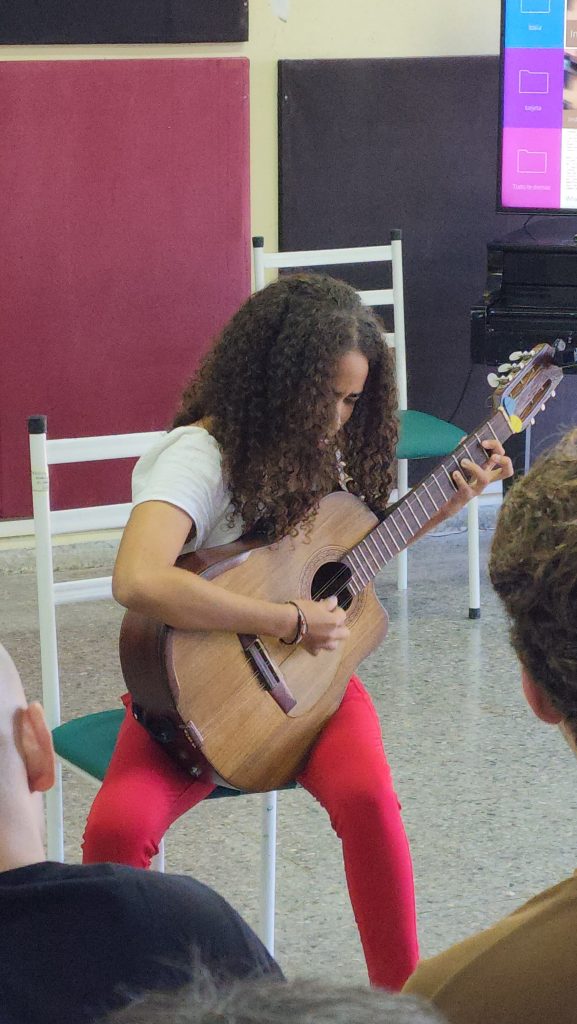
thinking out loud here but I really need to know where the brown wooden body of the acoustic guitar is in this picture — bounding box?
[120,493,388,792]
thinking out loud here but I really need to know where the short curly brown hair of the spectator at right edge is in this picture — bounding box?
[489,430,577,737]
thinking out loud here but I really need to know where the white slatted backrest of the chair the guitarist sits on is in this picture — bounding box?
[28,416,163,729]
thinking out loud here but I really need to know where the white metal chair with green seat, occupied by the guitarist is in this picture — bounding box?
[29,416,284,953]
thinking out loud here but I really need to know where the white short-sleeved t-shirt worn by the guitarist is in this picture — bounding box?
[132,427,244,554]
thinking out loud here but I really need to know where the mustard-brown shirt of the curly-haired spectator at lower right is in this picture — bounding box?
[404,876,577,1024]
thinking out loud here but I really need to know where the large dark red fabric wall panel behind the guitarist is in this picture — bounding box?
[0,58,250,518]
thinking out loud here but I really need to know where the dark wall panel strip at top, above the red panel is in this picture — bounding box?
[0,0,248,44]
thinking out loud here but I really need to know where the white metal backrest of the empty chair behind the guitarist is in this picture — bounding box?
[252,230,407,409]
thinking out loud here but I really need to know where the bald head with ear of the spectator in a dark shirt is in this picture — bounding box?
[0,645,54,871]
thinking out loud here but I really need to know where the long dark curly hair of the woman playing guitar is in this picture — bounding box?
[172,273,398,541]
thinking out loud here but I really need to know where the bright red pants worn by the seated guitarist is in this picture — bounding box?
[84,676,418,990]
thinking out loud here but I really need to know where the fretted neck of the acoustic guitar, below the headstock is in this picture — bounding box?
[342,410,511,593]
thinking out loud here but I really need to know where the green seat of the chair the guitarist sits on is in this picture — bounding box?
[52,709,296,800]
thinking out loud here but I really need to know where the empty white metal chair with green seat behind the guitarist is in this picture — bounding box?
[252,229,481,618]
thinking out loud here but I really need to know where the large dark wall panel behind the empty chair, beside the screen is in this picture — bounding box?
[279,56,577,452]
